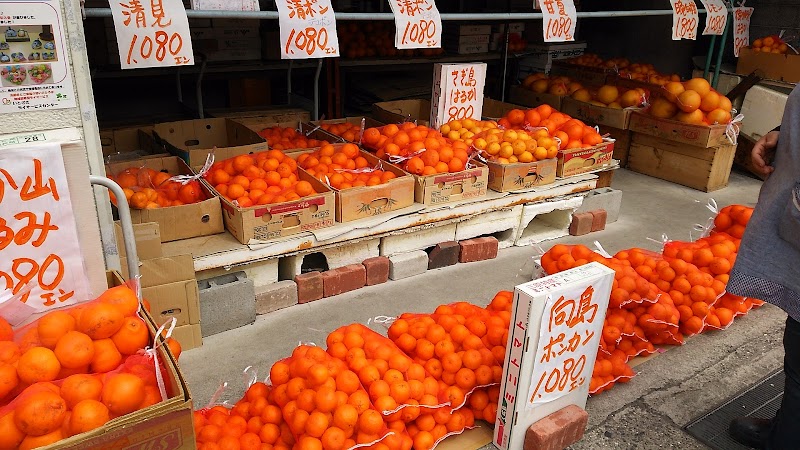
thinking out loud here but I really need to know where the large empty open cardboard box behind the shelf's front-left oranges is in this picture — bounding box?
[154,119,269,168]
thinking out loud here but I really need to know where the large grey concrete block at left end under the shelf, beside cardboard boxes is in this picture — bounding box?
[197,272,256,337]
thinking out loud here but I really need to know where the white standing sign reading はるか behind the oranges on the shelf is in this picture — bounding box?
[430,63,486,128]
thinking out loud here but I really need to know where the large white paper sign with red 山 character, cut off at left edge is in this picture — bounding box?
[0,144,90,311]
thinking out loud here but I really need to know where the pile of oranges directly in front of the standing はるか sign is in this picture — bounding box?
[361,122,476,176]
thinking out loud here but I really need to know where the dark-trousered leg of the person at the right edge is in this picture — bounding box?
[767,317,800,450]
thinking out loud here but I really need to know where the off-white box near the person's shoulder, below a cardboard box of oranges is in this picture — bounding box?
[739,85,789,140]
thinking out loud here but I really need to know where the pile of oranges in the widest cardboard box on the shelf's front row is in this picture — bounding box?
[205,150,317,208]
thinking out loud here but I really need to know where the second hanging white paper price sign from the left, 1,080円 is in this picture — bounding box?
[275,0,339,59]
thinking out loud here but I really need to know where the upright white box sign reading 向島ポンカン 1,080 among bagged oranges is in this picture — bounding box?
[494,263,614,450]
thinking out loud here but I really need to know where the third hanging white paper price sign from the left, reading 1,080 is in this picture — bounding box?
[389,0,442,50]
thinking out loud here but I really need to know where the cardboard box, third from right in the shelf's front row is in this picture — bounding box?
[414,161,489,205]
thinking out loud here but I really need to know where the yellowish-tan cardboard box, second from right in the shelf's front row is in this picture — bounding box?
[486,158,558,192]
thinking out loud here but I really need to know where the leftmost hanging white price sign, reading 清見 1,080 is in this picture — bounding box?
[110,0,194,69]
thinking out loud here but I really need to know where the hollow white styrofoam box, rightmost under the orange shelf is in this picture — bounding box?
[514,196,583,247]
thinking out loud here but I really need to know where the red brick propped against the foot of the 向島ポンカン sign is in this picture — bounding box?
[522,405,589,450]
